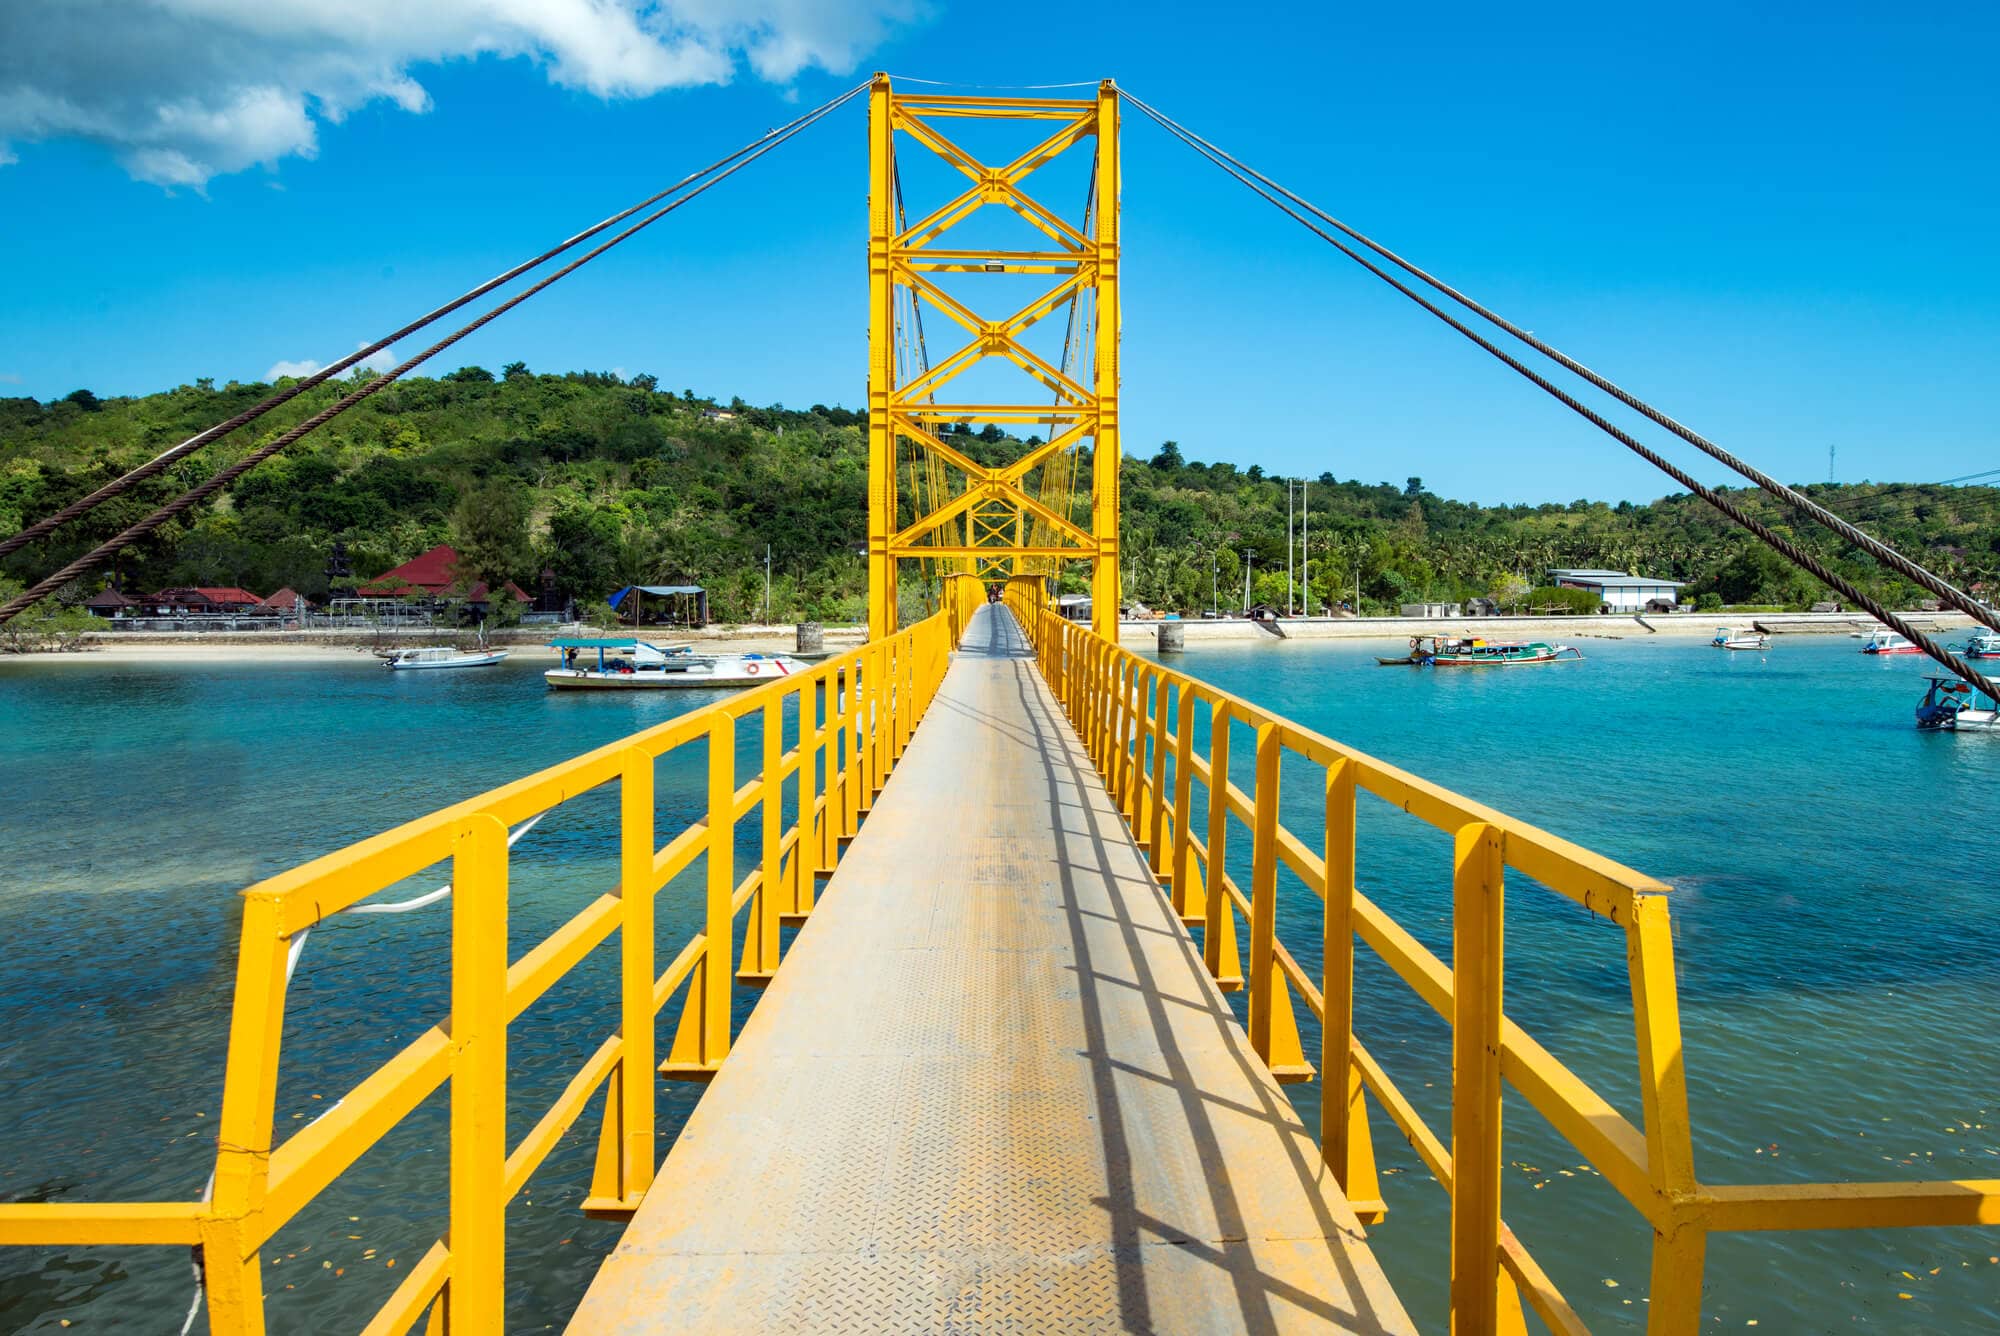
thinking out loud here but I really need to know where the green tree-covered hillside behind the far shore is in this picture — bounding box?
[0,362,2000,620]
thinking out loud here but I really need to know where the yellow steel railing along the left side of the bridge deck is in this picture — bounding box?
[0,612,960,1336]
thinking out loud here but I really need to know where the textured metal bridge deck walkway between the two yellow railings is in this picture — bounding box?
[570,608,1412,1336]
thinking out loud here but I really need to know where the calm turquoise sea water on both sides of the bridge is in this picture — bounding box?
[0,638,2000,1332]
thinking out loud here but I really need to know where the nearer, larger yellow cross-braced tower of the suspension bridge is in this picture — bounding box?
[868,74,1118,636]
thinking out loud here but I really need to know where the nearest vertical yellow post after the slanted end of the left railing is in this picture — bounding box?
[444,812,508,1336]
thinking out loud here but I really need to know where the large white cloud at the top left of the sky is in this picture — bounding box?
[0,0,926,188]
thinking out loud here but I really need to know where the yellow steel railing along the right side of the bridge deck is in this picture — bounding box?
[1006,578,2000,1336]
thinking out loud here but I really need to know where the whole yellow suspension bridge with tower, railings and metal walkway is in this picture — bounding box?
[0,76,2000,1336]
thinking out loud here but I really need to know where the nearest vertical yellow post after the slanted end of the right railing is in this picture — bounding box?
[1452,822,1506,1336]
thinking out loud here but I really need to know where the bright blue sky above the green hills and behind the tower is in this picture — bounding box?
[0,0,2000,502]
